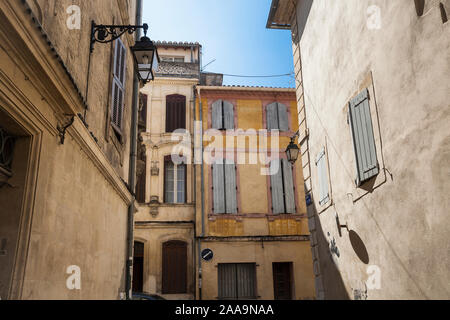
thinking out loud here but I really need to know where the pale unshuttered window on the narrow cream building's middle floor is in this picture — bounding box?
[164,156,187,203]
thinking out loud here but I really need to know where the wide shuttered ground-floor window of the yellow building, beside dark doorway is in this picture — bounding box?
[218,263,257,300]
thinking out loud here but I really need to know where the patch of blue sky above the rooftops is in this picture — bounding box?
[143,0,295,87]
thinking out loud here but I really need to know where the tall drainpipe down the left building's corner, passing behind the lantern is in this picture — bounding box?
[125,0,142,300]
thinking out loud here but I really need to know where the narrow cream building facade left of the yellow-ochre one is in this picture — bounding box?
[133,42,201,299]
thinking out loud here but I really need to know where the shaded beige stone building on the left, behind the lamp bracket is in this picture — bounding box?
[0,0,142,299]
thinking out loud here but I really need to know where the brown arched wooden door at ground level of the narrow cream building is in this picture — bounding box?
[162,241,187,294]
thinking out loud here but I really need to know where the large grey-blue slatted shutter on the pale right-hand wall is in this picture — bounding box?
[349,89,379,186]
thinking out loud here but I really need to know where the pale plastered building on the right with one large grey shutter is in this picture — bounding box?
[267,0,450,299]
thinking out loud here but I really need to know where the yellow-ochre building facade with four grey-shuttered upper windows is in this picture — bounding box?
[194,86,314,300]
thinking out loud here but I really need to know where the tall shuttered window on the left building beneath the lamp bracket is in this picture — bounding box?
[111,39,127,133]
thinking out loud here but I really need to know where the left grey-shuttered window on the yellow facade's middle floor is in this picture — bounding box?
[212,159,238,214]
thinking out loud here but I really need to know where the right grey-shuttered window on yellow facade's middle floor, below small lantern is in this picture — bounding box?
[270,159,297,214]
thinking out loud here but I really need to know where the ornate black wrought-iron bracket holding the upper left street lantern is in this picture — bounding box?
[91,21,148,53]
